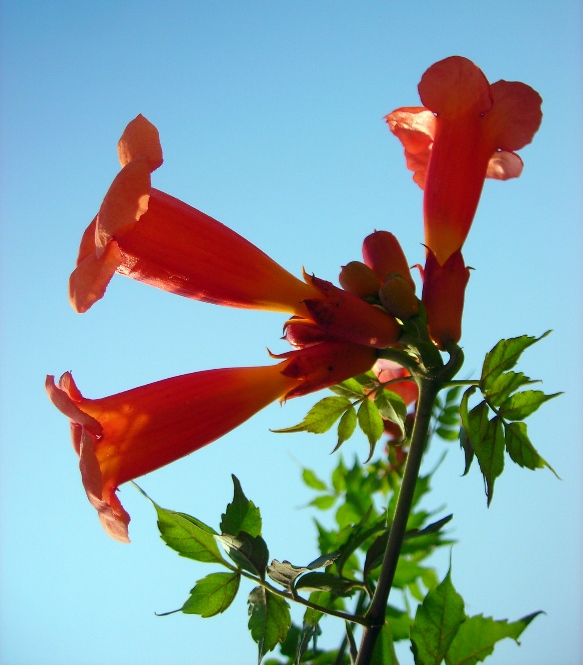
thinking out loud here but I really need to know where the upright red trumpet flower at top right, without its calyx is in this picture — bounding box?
[386,56,542,266]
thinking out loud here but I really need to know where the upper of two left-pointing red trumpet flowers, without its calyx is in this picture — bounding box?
[69,115,324,314]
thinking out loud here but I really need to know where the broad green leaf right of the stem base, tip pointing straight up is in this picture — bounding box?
[411,570,466,665]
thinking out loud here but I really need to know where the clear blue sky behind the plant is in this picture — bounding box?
[0,0,582,665]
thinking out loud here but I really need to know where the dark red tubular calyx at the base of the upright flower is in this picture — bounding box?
[422,251,470,350]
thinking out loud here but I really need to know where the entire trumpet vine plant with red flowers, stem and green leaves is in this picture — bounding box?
[46,56,556,665]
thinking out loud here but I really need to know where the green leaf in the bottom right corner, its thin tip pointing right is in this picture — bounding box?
[445,612,540,665]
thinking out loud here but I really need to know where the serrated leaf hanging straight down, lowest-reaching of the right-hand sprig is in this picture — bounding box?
[469,410,504,505]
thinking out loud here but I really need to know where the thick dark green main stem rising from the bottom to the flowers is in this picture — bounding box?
[355,378,442,665]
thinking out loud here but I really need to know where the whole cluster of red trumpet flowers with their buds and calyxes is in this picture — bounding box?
[46,57,541,542]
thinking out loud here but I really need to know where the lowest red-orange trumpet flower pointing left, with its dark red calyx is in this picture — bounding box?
[46,342,375,542]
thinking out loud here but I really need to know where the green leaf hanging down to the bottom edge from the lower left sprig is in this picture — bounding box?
[248,586,291,663]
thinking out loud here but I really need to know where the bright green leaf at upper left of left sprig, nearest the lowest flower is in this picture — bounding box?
[152,502,226,564]
